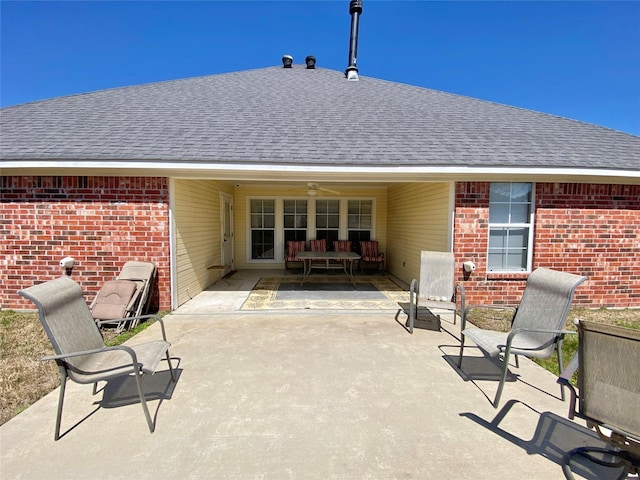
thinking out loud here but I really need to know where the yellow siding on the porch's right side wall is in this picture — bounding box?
[387,183,453,283]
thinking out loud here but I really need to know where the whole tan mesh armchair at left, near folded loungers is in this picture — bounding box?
[18,277,175,440]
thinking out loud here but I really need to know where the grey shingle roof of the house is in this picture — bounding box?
[0,65,640,171]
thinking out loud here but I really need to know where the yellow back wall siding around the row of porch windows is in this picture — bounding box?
[233,184,387,269]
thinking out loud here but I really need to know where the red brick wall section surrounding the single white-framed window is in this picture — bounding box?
[454,182,640,308]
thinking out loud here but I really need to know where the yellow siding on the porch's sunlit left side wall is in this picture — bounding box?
[173,180,233,305]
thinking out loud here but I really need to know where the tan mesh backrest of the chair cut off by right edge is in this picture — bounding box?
[578,320,640,439]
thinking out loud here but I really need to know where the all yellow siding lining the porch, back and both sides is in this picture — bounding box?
[173,180,453,305]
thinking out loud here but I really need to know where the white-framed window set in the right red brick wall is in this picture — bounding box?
[487,183,533,272]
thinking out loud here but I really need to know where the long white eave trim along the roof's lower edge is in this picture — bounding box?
[1,160,640,184]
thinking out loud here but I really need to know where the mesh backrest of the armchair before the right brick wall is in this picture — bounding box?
[511,268,587,356]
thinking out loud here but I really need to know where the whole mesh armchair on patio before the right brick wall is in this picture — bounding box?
[458,268,586,408]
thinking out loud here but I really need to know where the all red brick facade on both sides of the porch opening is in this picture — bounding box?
[0,176,640,310]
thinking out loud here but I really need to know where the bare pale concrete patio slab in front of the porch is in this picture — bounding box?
[0,270,602,480]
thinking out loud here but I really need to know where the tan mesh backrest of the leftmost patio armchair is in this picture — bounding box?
[18,277,104,365]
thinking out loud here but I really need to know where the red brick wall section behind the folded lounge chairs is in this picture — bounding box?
[0,176,171,310]
